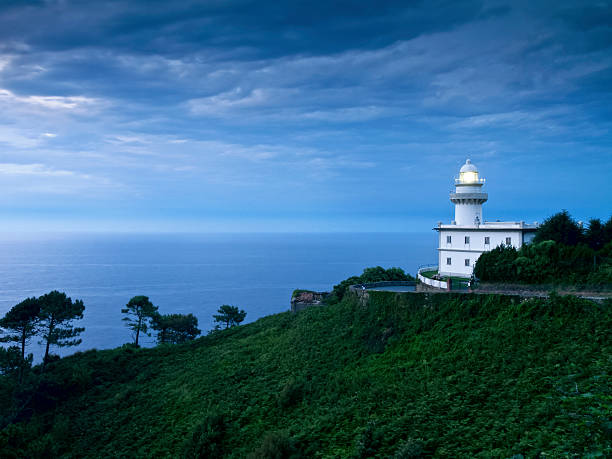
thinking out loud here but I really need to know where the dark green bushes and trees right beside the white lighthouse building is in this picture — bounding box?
[474,211,612,289]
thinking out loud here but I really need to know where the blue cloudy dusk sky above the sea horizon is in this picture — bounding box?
[0,0,612,234]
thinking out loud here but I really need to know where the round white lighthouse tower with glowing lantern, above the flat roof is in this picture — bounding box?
[450,159,489,227]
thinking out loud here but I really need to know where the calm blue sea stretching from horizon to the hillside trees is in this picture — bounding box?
[0,233,436,354]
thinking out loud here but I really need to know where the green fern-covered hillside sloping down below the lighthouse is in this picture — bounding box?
[0,292,612,457]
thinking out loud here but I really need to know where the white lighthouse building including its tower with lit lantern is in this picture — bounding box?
[434,159,538,277]
